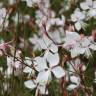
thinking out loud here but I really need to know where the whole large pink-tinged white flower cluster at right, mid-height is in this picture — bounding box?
[63,32,96,58]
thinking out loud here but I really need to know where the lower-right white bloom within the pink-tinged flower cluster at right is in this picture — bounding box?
[70,37,92,58]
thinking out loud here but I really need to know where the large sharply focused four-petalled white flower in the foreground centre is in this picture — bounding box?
[34,53,65,83]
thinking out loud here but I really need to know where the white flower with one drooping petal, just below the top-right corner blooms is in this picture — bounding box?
[71,8,86,31]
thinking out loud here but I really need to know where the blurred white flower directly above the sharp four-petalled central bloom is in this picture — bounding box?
[29,31,58,53]
